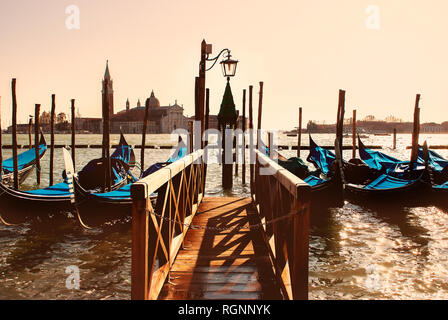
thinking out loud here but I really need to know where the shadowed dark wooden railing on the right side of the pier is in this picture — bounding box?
[251,150,311,300]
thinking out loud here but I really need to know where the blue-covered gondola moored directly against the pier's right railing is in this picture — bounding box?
[278,135,343,208]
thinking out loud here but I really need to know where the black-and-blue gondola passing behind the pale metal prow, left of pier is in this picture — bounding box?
[0,134,135,223]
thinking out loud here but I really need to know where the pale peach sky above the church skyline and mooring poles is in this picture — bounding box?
[0,0,448,130]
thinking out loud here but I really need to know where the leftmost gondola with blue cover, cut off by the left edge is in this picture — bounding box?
[1,133,47,186]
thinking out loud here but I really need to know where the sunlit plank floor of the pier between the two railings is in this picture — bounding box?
[159,198,282,300]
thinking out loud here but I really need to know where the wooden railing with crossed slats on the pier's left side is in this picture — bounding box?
[131,150,205,300]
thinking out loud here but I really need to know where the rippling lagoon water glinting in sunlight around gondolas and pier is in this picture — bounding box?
[0,134,448,299]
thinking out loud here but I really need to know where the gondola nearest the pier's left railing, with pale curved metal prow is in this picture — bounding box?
[66,143,187,225]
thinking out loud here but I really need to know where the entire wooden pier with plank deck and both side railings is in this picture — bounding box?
[131,150,310,300]
